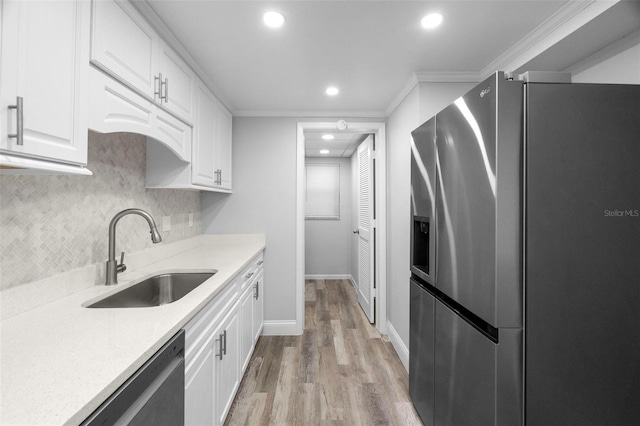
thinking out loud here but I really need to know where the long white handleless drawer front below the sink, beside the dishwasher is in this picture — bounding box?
[184,278,238,362]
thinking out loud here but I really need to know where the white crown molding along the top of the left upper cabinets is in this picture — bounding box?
[131,0,235,115]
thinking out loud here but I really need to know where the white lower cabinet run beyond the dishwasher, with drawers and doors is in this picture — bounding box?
[184,253,263,426]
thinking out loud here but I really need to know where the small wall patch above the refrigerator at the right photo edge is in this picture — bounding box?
[567,31,640,84]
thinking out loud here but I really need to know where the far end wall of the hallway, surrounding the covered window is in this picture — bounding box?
[305,157,352,276]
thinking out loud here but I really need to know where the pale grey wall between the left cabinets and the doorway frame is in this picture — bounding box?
[201,117,381,334]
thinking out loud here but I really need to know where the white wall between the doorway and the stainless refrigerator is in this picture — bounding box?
[387,83,476,367]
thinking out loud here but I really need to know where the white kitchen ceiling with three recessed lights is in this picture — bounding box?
[144,0,640,117]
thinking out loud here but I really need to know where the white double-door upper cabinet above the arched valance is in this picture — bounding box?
[91,0,195,123]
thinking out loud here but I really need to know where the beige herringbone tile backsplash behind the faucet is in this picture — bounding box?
[0,132,202,290]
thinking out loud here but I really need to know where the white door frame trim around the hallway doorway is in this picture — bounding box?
[296,122,387,334]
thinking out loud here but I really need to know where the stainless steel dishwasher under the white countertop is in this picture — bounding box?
[82,330,184,426]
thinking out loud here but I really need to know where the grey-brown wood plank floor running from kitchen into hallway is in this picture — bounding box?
[225,280,422,426]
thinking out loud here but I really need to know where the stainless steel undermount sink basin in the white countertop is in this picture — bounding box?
[87,271,217,308]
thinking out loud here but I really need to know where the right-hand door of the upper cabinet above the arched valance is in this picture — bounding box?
[159,43,196,123]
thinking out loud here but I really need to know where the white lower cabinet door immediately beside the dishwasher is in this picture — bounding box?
[184,338,218,426]
